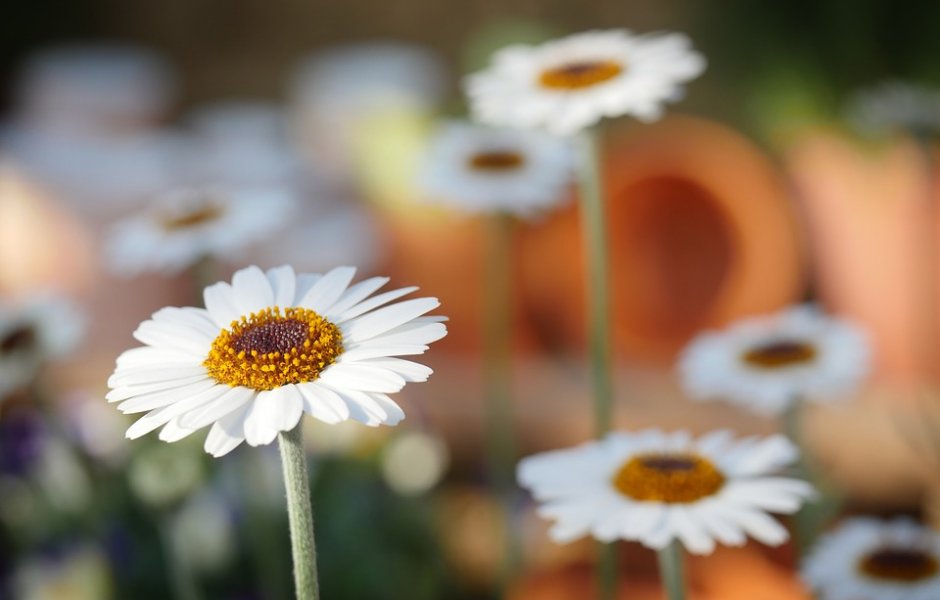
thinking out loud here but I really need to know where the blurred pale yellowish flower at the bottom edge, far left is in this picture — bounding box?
[13,545,114,600]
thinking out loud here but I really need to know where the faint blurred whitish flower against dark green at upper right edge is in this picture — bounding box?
[847,81,940,135]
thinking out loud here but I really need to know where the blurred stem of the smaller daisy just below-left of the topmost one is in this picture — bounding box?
[483,214,521,588]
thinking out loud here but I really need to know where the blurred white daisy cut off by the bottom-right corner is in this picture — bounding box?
[801,517,940,600]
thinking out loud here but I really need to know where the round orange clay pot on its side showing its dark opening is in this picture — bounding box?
[521,117,804,362]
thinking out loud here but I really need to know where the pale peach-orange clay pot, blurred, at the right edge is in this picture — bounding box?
[787,131,940,383]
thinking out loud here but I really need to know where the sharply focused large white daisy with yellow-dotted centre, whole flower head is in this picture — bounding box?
[107,266,447,456]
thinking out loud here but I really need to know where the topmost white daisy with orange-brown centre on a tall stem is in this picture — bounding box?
[465,29,705,135]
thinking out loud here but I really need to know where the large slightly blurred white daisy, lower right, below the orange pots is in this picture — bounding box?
[518,429,813,554]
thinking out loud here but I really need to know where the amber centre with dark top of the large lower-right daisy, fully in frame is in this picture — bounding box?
[612,453,725,504]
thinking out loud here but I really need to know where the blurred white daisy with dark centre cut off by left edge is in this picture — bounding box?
[0,294,85,400]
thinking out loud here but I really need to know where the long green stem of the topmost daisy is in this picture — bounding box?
[576,130,617,600]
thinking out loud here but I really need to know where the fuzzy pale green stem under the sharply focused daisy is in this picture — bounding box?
[277,422,320,600]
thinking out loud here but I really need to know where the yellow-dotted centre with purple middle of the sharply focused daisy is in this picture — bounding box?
[202,306,343,391]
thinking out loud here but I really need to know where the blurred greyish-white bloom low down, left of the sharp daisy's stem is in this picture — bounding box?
[170,492,237,573]
